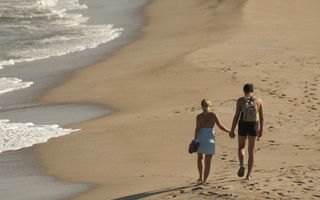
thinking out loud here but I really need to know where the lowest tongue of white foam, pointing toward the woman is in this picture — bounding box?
[0,120,79,153]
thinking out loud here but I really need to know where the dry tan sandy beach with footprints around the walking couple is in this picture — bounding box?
[35,0,320,200]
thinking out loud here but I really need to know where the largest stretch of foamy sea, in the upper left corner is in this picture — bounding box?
[0,0,122,67]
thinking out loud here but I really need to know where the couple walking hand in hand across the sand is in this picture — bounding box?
[194,84,263,184]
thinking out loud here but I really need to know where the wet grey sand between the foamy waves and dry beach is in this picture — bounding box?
[0,0,150,199]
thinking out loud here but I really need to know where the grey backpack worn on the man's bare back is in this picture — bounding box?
[241,97,257,122]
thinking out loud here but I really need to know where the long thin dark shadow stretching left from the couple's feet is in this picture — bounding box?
[113,179,243,200]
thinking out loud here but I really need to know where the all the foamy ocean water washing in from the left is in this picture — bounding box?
[0,0,122,152]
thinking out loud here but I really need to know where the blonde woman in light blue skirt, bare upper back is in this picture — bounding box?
[194,99,230,184]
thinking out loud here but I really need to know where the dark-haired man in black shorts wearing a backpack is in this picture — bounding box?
[230,83,263,180]
